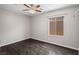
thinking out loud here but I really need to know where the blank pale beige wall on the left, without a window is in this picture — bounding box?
[0,9,30,46]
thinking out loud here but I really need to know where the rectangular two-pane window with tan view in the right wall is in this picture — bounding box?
[49,16,64,35]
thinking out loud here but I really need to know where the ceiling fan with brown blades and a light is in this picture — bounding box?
[23,4,42,12]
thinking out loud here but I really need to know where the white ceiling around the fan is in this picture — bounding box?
[0,4,77,16]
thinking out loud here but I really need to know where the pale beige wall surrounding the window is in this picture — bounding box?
[32,7,79,50]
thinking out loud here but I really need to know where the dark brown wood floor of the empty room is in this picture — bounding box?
[0,39,78,55]
